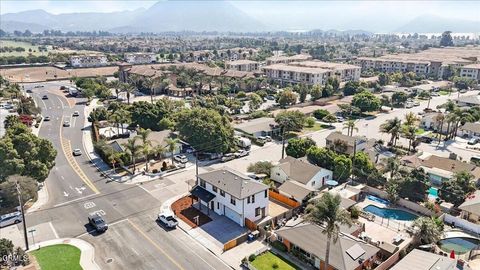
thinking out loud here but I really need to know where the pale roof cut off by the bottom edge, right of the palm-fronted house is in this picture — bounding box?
[390,249,461,270]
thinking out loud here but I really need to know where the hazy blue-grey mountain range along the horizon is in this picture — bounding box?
[0,0,480,33]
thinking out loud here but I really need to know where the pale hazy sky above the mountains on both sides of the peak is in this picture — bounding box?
[0,0,480,31]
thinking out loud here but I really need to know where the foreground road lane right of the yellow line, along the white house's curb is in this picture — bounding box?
[129,212,231,269]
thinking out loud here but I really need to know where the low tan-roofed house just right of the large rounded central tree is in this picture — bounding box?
[234,117,280,138]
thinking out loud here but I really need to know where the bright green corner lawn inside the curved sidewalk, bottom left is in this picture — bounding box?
[31,244,82,270]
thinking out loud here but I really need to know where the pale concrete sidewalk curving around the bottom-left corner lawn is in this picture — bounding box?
[30,238,100,270]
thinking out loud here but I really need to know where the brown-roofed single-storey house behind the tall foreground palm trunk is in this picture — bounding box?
[276,224,380,270]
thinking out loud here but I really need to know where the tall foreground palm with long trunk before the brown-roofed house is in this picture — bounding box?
[306,192,352,269]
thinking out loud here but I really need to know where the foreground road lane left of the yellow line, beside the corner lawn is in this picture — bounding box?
[80,220,187,270]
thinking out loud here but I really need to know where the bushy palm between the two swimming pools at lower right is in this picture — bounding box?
[413,217,443,245]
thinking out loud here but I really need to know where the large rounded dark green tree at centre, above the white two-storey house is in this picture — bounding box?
[176,108,233,153]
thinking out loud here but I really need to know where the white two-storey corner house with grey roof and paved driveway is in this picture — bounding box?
[191,167,269,227]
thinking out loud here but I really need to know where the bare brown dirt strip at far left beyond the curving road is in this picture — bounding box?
[0,66,118,83]
